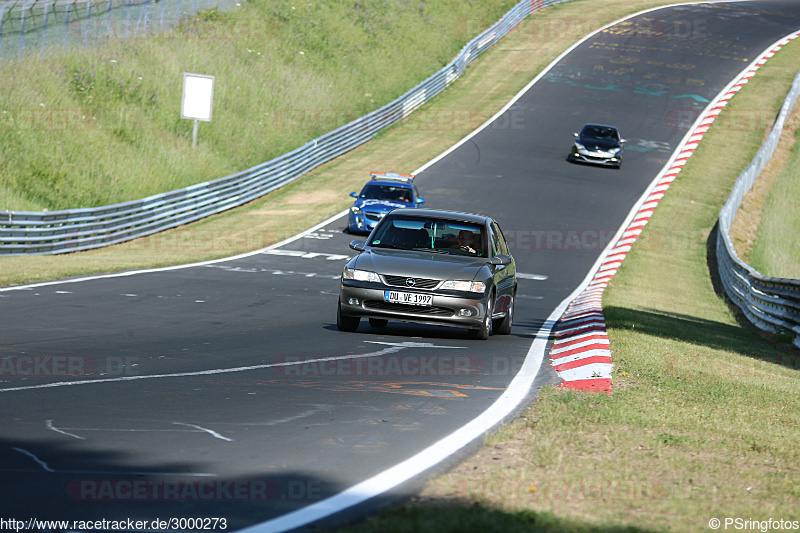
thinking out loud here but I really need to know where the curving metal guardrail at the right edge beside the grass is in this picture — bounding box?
[717,67,800,348]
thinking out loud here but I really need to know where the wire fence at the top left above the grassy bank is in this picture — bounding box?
[0,0,238,61]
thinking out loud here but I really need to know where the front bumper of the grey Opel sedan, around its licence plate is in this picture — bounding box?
[339,281,489,328]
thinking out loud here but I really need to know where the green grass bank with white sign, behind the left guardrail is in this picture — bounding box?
[0,0,515,211]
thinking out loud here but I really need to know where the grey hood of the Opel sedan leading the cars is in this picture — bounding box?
[354,248,488,281]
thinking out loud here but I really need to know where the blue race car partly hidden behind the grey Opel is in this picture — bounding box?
[347,172,425,233]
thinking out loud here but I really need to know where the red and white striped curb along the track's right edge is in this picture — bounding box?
[550,31,800,393]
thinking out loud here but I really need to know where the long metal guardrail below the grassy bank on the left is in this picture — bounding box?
[0,0,568,256]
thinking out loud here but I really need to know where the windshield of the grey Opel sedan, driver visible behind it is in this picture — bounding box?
[367,216,488,257]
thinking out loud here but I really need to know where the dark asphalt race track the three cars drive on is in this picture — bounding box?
[0,1,800,530]
